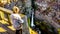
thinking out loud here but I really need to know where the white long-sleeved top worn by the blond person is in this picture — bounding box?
[10,14,23,30]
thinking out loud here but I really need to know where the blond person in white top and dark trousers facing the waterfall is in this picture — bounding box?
[10,6,23,34]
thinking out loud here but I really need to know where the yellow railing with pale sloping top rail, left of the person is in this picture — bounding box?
[0,7,12,25]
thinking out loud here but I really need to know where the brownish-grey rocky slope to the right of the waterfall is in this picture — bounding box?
[35,0,60,29]
